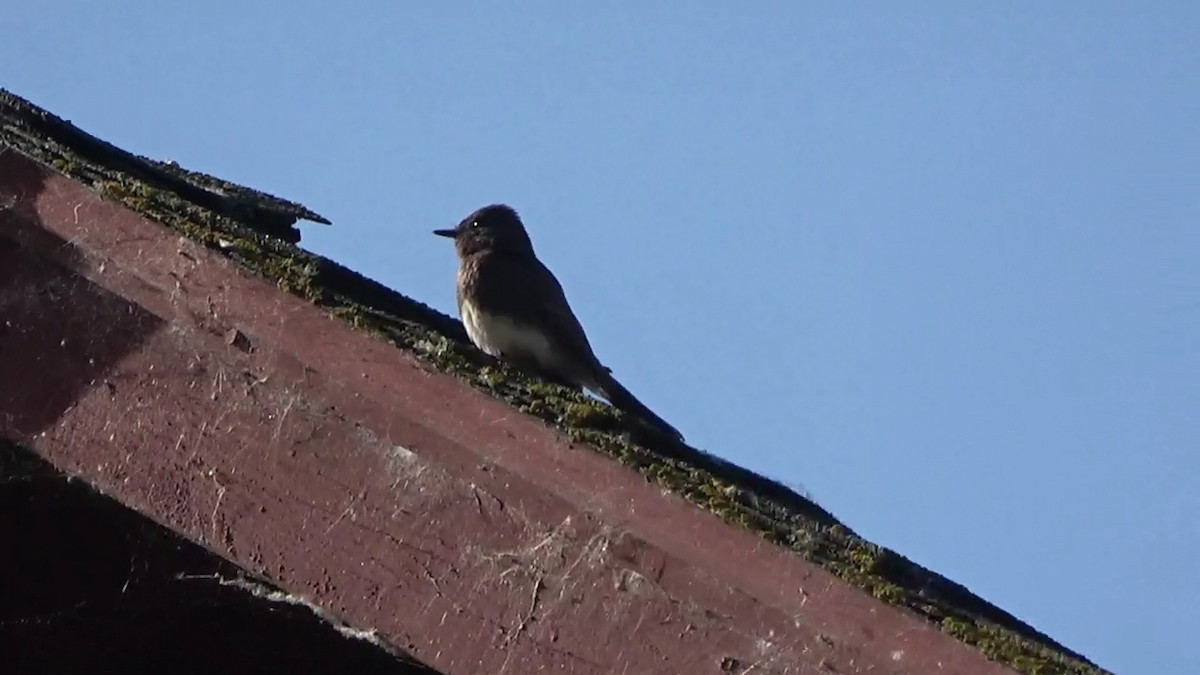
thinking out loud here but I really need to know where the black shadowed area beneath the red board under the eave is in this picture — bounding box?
[0,441,438,675]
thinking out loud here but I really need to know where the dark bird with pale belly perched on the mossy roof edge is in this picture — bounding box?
[433,204,683,441]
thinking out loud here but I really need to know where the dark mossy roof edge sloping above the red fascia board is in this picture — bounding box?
[0,89,1105,675]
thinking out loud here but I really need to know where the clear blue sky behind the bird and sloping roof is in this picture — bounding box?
[0,0,1200,675]
